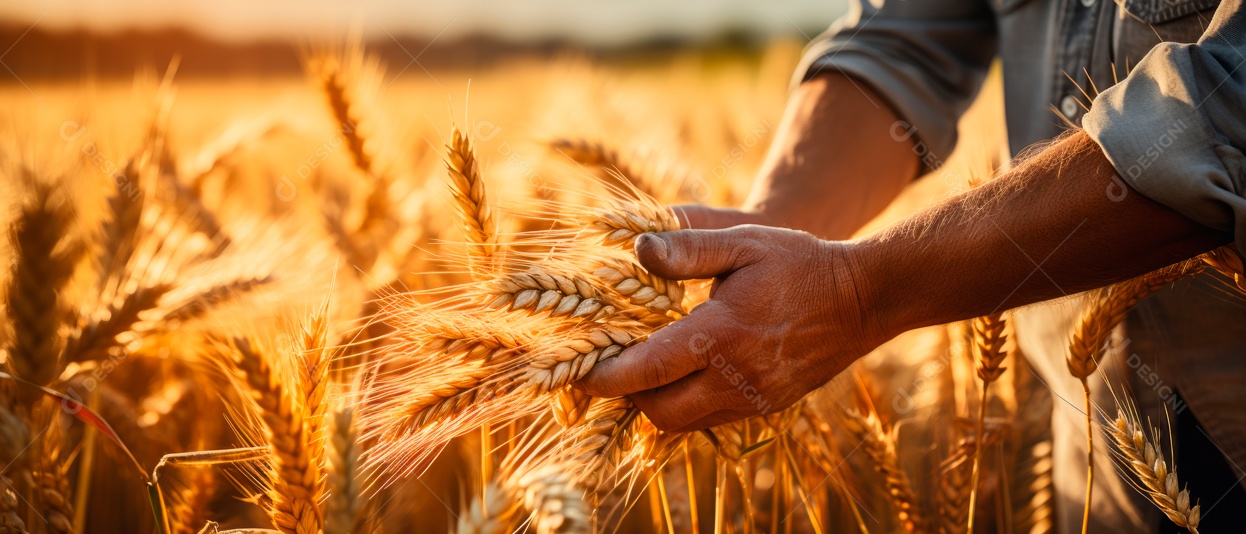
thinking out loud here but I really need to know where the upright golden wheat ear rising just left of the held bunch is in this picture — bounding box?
[446,122,497,278]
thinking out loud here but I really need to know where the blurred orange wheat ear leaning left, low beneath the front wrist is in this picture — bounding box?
[844,410,925,533]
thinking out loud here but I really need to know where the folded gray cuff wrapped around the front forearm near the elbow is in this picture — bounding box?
[1082,44,1246,250]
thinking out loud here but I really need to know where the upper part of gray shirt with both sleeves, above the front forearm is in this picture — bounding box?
[797,0,1246,255]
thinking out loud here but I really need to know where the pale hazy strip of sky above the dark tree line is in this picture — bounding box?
[0,0,845,45]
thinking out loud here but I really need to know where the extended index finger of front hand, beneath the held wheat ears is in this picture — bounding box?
[577,301,725,397]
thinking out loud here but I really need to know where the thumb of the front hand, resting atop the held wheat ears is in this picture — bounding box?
[635,227,760,280]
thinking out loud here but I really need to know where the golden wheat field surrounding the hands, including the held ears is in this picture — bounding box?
[0,41,1242,534]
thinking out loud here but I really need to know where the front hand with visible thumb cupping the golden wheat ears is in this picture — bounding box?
[578,225,887,432]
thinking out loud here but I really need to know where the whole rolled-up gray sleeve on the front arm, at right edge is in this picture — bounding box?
[1083,0,1246,251]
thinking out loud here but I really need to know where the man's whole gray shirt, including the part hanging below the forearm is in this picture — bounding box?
[796,0,1246,533]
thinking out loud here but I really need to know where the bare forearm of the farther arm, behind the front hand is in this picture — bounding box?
[745,73,920,239]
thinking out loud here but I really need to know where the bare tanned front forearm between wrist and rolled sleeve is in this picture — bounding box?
[847,132,1230,334]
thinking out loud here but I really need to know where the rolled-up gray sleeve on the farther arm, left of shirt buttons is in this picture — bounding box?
[796,0,998,158]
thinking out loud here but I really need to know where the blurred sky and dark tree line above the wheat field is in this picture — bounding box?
[0,0,846,82]
